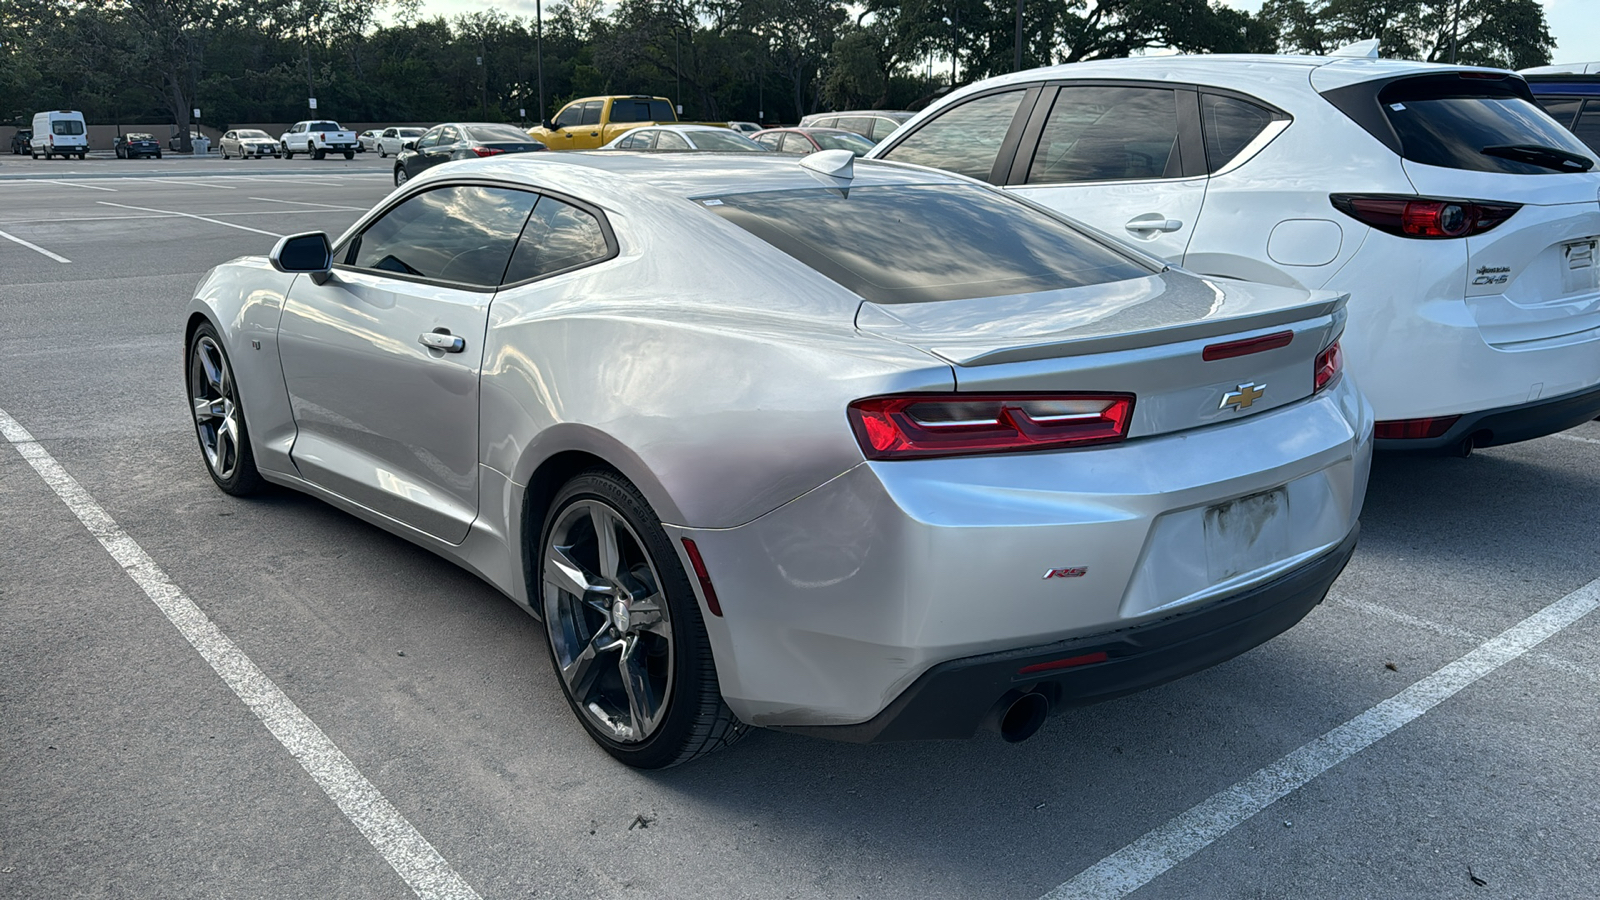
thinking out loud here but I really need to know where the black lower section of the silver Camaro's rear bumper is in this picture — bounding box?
[778,525,1360,743]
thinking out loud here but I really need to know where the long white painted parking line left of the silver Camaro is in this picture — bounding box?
[0,410,480,900]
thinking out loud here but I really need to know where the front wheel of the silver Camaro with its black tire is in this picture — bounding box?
[184,322,266,496]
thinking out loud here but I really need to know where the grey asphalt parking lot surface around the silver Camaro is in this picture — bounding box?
[0,154,1600,900]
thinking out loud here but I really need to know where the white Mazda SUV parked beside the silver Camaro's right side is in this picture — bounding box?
[869,48,1600,453]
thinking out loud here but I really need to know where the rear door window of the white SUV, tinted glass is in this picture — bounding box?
[1027,86,1181,184]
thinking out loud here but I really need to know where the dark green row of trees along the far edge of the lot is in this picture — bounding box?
[0,0,1554,130]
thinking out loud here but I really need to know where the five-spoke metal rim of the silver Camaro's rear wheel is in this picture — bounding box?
[542,500,674,743]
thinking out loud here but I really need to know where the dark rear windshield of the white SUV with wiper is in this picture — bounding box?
[1378,75,1594,175]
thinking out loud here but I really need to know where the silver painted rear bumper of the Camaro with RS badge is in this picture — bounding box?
[667,378,1373,727]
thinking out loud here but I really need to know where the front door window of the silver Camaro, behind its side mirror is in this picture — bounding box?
[344,184,538,288]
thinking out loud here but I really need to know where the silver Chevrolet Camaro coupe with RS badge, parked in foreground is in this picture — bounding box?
[186,151,1373,767]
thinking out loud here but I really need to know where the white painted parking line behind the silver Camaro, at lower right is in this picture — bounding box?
[1043,578,1600,900]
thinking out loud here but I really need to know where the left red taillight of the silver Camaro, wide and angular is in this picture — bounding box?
[850,394,1133,460]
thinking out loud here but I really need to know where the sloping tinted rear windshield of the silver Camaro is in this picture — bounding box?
[699,184,1152,303]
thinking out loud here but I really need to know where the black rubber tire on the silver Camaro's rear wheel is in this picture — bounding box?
[533,468,749,769]
